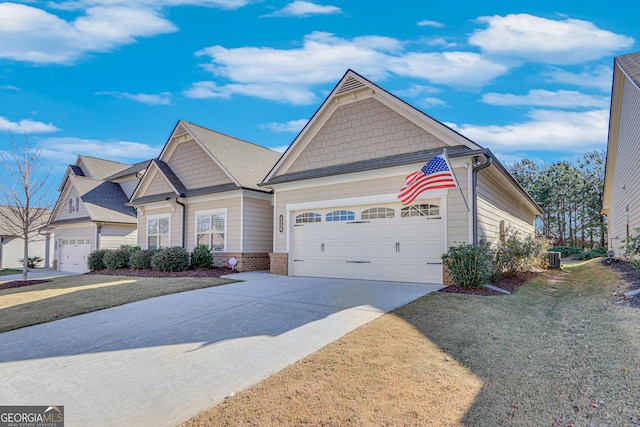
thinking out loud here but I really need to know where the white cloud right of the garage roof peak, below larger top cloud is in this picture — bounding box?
[389,52,509,87]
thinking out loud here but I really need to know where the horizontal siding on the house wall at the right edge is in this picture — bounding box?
[608,77,640,256]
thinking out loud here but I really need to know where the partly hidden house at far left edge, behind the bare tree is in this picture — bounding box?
[0,206,53,268]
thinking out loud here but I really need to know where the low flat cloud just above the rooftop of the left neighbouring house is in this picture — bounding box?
[38,137,159,165]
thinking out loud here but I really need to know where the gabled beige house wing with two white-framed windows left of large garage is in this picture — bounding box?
[131,121,281,271]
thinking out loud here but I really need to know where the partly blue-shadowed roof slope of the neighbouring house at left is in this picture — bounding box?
[69,176,136,224]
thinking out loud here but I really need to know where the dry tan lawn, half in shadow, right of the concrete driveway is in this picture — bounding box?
[183,262,640,427]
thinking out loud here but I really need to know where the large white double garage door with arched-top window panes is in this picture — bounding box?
[291,201,442,283]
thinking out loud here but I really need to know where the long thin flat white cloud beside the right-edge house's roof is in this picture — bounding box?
[482,89,609,109]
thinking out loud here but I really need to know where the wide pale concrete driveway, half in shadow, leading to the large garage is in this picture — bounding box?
[0,273,441,427]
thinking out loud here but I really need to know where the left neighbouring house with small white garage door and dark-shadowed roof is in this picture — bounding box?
[49,156,149,273]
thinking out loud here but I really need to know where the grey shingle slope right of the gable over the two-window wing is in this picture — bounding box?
[180,121,281,191]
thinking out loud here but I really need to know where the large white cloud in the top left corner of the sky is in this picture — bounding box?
[0,3,176,64]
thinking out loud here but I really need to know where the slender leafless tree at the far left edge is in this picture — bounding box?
[0,132,53,280]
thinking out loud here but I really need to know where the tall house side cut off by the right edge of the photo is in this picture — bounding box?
[602,52,640,256]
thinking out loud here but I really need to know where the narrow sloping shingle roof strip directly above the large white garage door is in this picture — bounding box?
[263,146,473,186]
